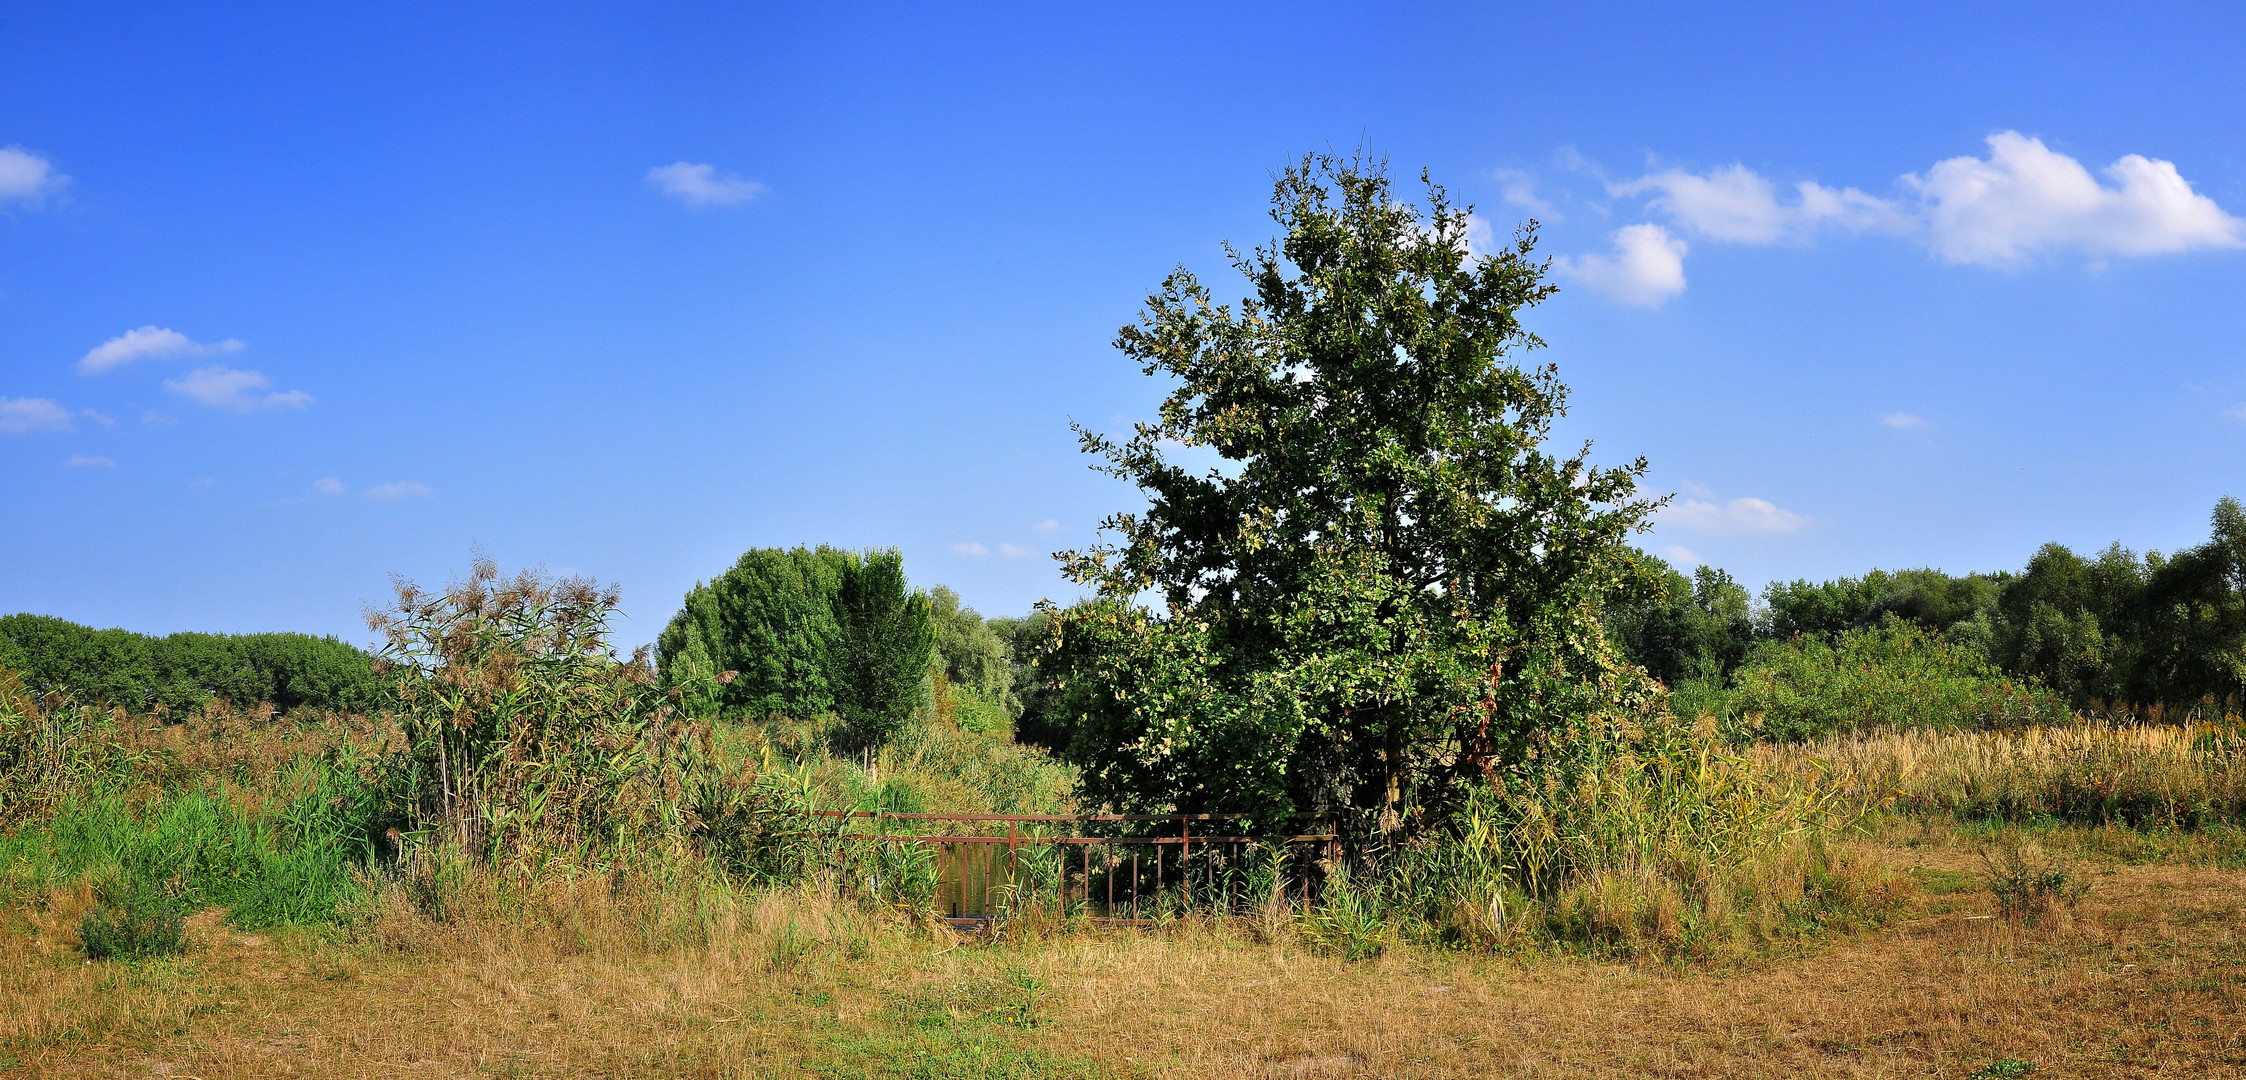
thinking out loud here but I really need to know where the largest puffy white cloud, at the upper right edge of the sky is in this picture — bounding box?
[1902,130,2246,265]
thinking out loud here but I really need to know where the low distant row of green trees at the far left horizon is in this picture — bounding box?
[0,615,382,712]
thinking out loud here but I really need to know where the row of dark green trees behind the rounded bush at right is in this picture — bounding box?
[1608,498,2246,716]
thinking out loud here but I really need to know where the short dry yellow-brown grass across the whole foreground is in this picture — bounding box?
[0,826,2246,1080]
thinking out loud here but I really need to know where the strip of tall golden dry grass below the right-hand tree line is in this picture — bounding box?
[1781,721,2246,829]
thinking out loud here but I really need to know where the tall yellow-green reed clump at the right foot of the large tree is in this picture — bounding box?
[1305,723,1887,957]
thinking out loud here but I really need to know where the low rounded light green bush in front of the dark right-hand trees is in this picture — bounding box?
[1673,617,2069,741]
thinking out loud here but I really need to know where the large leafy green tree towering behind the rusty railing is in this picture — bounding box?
[1042,157,1658,829]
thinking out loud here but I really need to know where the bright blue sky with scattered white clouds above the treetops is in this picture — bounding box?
[0,2,2246,642]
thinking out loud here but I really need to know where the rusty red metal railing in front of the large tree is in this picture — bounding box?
[813,811,1339,925]
